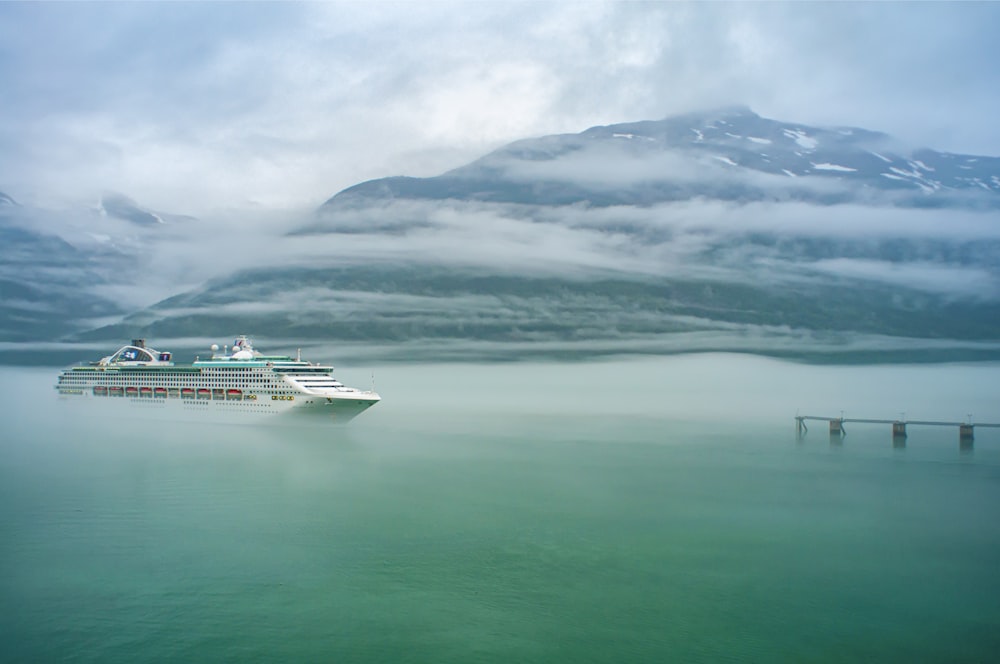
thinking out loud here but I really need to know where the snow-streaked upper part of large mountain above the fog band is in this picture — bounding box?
[303,107,1000,232]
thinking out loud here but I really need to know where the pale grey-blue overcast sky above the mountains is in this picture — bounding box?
[0,2,1000,214]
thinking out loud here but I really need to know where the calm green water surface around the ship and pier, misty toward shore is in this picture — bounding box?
[0,356,1000,663]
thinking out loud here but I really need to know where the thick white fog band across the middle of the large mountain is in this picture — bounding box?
[88,201,1000,307]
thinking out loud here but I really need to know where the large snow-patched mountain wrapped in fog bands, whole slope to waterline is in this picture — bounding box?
[9,107,1000,362]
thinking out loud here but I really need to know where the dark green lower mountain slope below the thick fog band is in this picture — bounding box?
[77,264,1000,362]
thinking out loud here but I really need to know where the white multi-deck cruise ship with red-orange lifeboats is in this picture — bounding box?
[55,335,381,422]
